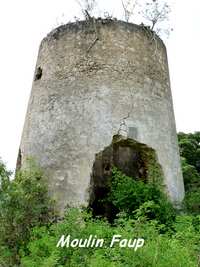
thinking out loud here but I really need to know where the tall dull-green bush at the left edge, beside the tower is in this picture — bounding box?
[0,161,55,267]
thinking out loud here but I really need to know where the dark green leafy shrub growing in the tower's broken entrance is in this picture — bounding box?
[108,168,175,229]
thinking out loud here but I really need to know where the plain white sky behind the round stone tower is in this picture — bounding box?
[0,0,200,170]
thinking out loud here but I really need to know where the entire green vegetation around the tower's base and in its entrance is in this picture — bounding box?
[0,133,200,267]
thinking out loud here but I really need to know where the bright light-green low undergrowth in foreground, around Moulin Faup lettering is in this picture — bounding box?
[21,209,199,267]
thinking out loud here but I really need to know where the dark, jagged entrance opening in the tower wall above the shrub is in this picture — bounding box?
[89,135,163,222]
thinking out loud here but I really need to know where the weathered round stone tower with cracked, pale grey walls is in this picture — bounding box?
[18,19,184,213]
